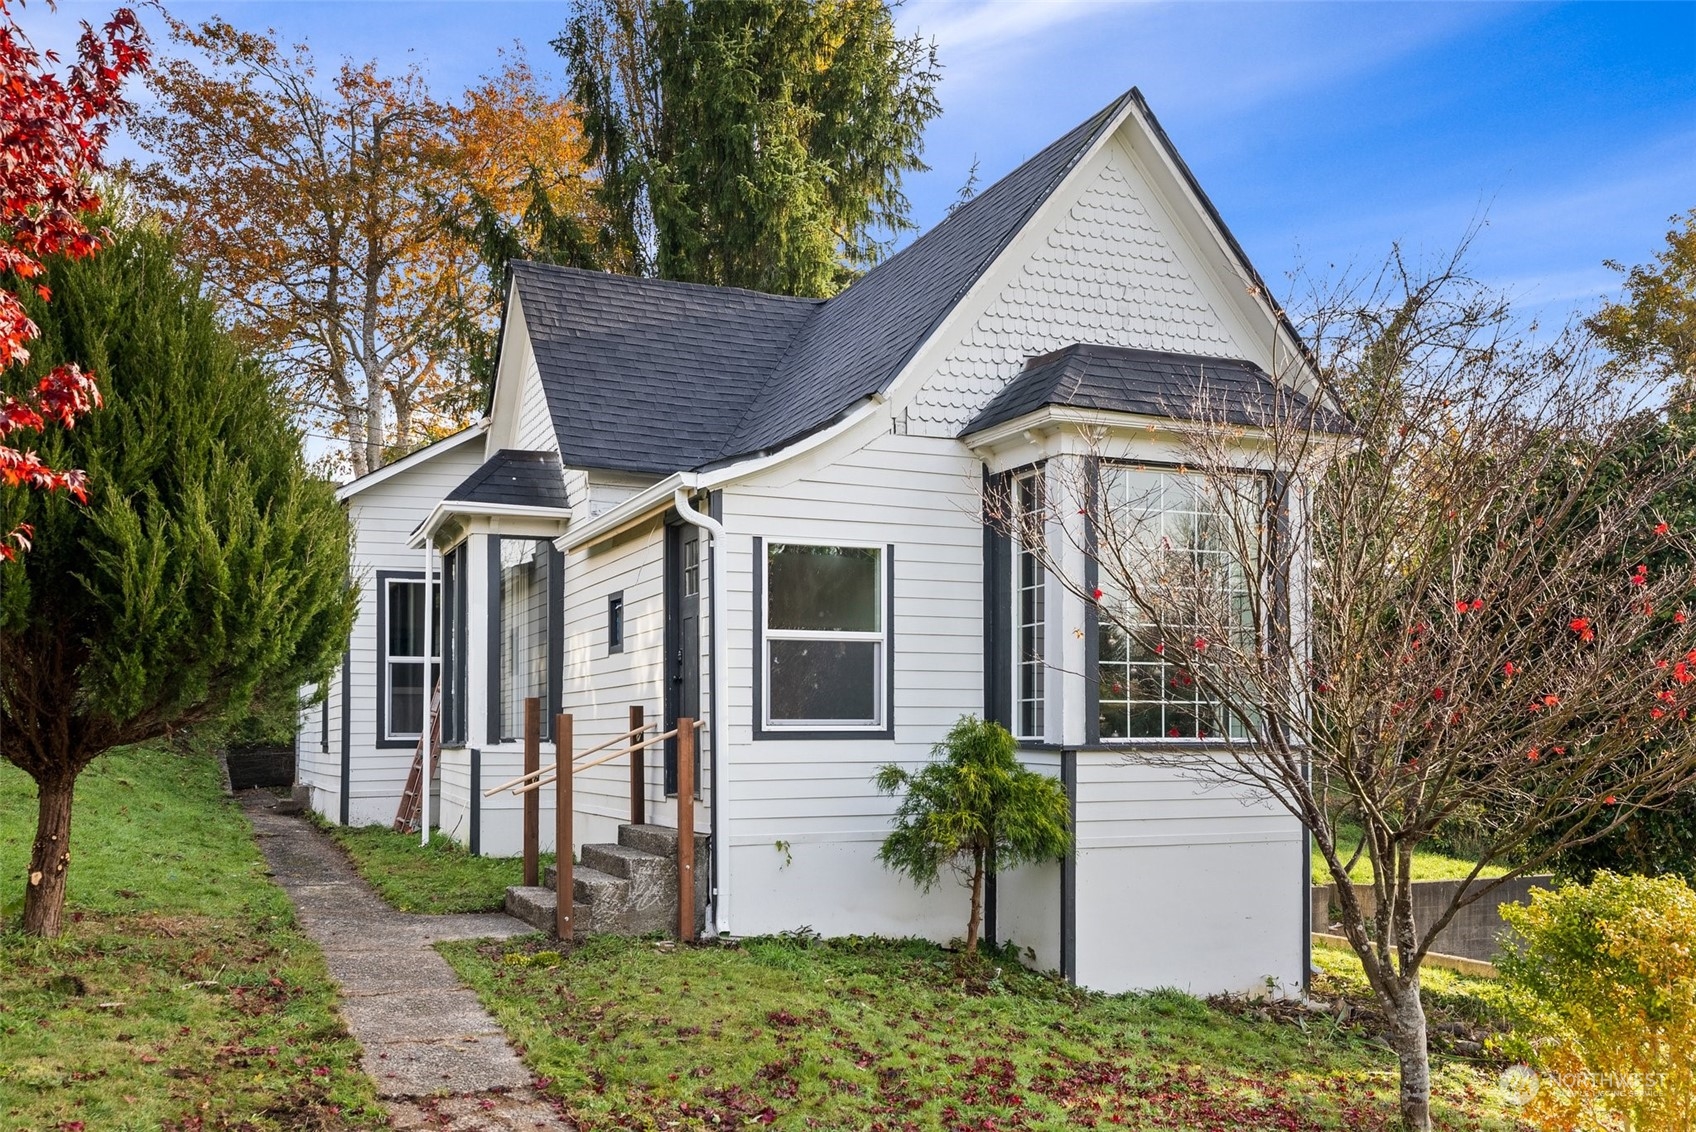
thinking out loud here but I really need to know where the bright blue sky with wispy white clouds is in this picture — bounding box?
[22,0,1696,327]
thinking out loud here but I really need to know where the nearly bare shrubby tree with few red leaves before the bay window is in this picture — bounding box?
[989,247,1696,1129]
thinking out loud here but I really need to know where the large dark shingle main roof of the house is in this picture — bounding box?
[512,92,1135,474]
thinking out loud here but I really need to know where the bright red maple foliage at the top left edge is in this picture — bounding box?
[0,0,148,562]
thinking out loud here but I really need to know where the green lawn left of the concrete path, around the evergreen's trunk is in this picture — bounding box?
[0,750,387,1132]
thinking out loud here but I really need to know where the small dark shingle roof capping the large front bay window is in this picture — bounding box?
[962,345,1308,436]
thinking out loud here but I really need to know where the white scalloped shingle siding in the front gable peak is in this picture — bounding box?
[911,141,1253,436]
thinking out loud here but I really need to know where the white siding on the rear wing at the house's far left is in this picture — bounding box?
[298,431,483,825]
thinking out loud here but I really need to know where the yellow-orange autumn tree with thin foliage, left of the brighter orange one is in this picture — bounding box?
[131,19,480,474]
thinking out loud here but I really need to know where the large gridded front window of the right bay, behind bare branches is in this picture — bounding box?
[1097,465,1253,740]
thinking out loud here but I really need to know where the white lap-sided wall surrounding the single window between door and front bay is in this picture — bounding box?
[724,434,984,940]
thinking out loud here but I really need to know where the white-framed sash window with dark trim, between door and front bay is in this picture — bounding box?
[763,543,889,730]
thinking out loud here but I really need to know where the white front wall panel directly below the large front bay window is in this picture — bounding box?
[1077,752,1306,995]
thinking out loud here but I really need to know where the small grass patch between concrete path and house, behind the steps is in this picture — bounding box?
[322,823,553,915]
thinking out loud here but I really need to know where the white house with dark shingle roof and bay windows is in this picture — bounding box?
[300,90,1309,993]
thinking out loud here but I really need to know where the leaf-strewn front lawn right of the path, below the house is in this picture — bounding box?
[439,937,1516,1132]
